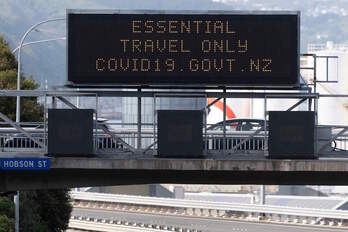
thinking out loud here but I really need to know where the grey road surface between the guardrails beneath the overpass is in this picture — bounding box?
[72,208,347,232]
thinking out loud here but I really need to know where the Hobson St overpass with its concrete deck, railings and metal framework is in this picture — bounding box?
[0,88,348,191]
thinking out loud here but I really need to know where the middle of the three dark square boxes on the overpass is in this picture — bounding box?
[157,110,203,158]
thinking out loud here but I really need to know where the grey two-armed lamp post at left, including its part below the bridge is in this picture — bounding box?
[13,18,65,232]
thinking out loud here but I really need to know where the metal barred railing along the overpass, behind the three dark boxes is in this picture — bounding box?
[0,123,348,154]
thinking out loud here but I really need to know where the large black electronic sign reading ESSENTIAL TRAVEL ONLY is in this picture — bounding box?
[67,10,299,88]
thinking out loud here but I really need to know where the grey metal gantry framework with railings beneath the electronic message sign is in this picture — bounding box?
[0,53,348,155]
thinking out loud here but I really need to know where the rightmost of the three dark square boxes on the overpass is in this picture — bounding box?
[268,111,317,159]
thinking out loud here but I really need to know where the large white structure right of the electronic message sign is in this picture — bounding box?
[301,42,348,125]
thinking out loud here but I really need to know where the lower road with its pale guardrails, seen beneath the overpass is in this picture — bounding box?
[69,192,348,232]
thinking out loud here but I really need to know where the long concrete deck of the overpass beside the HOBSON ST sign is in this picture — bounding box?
[0,153,348,191]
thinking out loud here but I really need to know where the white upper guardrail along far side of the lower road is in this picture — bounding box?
[71,192,348,220]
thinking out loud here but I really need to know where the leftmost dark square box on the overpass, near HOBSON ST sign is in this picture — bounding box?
[48,109,94,156]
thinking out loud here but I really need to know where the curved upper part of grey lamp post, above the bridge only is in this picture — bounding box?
[16,18,65,123]
